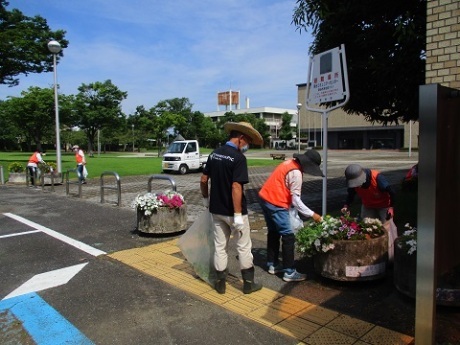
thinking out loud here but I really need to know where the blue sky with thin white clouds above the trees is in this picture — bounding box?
[0,0,312,115]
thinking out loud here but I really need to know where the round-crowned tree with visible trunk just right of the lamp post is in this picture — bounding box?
[74,80,128,151]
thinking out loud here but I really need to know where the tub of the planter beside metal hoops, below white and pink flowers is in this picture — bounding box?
[137,205,187,234]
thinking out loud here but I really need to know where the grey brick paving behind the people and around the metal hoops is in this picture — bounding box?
[36,151,418,228]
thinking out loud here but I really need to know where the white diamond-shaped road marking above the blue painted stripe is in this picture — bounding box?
[3,262,88,300]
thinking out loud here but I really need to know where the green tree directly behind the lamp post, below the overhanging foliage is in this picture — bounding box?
[2,87,71,150]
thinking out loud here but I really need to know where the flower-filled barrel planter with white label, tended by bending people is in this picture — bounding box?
[296,215,388,281]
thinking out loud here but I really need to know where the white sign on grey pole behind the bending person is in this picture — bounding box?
[305,44,350,216]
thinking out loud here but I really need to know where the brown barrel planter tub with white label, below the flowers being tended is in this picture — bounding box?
[313,234,388,281]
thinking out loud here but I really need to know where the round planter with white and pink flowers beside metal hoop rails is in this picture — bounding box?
[131,191,187,234]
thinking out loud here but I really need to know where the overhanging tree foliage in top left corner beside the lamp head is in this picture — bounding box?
[0,0,69,86]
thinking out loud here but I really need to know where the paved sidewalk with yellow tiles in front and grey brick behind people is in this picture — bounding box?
[0,151,424,345]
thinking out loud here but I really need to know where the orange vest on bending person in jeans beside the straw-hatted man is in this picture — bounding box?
[259,159,301,209]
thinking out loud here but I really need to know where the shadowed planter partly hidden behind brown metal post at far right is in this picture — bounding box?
[393,238,460,307]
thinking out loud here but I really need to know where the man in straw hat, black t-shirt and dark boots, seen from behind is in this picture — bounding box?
[200,122,263,294]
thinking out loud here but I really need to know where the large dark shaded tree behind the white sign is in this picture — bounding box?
[292,0,426,124]
